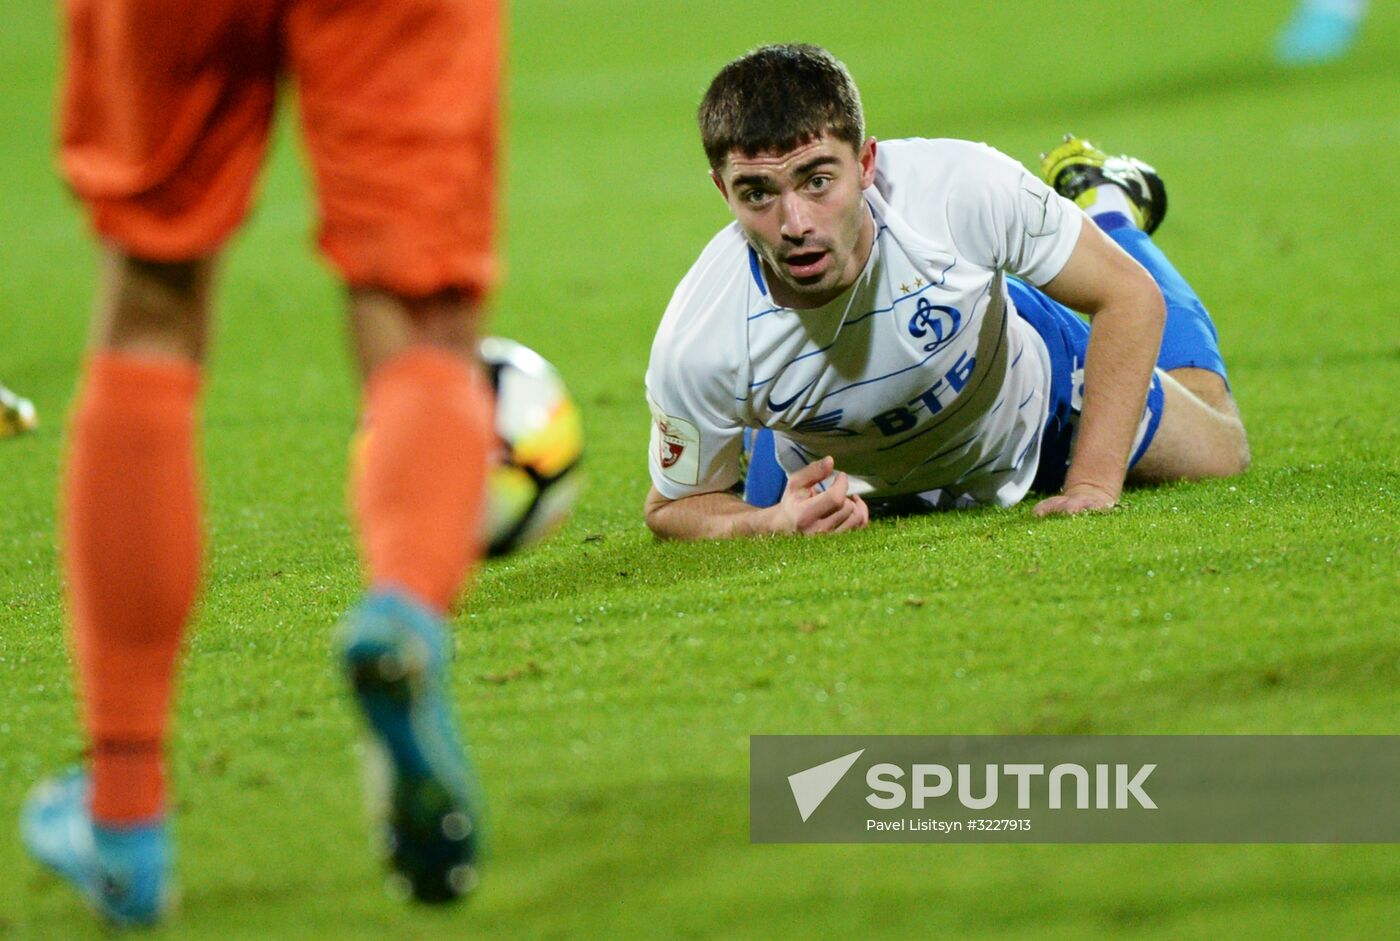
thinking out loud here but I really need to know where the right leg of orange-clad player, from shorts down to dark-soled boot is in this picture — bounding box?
[287,0,500,902]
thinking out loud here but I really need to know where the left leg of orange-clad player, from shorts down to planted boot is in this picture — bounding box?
[21,0,276,924]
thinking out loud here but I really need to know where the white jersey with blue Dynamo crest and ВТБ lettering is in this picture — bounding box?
[647,139,1084,506]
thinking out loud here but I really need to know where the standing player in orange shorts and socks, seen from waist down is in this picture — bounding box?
[21,0,500,924]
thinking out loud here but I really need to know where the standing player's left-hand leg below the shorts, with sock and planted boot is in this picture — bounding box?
[24,253,209,923]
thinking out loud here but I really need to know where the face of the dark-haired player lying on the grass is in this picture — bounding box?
[713,134,875,308]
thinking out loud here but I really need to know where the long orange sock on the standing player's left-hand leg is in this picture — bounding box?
[63,353,200,823]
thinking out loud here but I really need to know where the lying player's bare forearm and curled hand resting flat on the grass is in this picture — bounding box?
[647,456,869,539]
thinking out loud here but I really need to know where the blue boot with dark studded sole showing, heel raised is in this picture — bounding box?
[340,591,480,903]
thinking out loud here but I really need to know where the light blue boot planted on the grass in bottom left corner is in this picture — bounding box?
[20,769,172,927]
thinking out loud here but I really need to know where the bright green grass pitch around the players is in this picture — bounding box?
[0,0,1400,941]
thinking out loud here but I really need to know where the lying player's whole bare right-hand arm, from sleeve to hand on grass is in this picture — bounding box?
[1035,218,1166,517]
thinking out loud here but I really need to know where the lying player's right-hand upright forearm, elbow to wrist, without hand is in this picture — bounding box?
[1064,290,1166,500]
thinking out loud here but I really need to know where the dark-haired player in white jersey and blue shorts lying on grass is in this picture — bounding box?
[645,46,1249,539]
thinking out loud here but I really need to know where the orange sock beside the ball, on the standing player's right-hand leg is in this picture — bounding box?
[351,346,494,612]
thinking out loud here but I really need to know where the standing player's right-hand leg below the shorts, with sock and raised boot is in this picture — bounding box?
[343,290,491,902]
